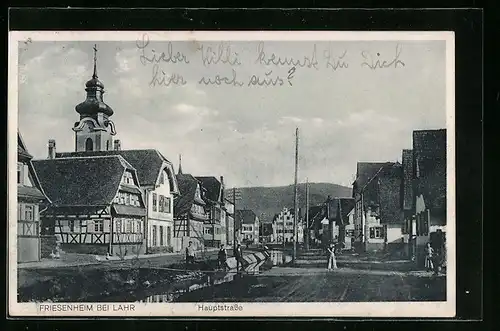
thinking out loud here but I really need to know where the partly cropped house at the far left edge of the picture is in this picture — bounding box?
[17,132,50,262]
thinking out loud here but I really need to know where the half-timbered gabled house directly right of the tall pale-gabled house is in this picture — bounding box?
[174,171,210,251]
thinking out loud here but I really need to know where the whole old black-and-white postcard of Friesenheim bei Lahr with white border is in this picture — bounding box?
[8,31,456,317]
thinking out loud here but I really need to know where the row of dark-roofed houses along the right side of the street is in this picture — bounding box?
[308,129,447,262]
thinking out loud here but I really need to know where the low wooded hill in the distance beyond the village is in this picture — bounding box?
[228,183,352,221]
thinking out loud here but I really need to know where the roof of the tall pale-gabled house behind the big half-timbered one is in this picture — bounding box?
[56,149,179,193]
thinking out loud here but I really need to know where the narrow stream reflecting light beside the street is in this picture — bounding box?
[139,250,292,303]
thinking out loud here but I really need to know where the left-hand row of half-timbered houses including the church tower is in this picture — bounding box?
[17,58,258,262]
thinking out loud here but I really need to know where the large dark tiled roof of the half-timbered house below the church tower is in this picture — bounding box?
[33,155,137,207]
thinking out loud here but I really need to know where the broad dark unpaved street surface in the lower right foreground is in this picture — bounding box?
[176,267,446,302]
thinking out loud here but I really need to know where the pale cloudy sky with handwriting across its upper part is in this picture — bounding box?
[18,38,446,187]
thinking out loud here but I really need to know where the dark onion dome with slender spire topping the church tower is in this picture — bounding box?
[75,47,113,117]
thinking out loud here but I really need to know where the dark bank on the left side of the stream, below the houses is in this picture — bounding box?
[18,252,264,302]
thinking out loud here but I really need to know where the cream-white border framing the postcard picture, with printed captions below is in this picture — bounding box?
[7,31,456,317]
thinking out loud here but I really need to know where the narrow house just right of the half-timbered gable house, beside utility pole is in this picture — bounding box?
[196,176,227,247]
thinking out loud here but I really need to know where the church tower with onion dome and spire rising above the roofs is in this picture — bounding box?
[73,45,116,152]
